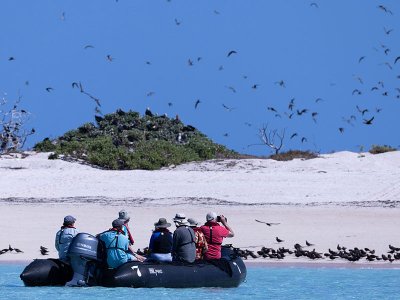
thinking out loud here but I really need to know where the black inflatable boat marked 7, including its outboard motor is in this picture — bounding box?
[20,233,247,288]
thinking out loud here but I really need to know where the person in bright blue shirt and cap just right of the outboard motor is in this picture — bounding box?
[98,219,144,269]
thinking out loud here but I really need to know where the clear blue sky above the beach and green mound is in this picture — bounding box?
[0,0,400,155]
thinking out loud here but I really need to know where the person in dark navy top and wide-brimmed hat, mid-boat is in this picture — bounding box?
[147,218,172,261]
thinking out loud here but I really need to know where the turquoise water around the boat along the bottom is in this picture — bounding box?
[0,265,400,300]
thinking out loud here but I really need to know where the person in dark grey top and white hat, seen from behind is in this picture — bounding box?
[172,213,196,263]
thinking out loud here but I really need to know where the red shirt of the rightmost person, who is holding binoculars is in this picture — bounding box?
[200,221,229,259]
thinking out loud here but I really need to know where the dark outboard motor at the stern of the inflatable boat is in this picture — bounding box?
[66,233,101,286]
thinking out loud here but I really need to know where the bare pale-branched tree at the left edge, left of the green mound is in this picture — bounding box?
[0,97,35,154]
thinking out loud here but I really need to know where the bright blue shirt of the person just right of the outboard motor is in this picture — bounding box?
[99,230,133,269]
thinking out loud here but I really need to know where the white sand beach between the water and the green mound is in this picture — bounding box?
[0,151,400,266]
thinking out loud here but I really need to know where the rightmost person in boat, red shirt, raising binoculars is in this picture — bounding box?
[200,212,235,259]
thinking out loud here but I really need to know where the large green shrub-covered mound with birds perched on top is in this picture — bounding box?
[34,110,238,170]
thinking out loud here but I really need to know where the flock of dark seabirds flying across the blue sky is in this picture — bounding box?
[4,0,400,152]
